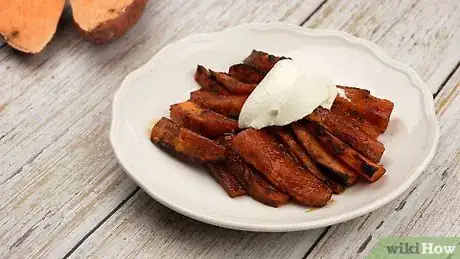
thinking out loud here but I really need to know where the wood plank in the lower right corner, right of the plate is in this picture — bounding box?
[308,69,460,258]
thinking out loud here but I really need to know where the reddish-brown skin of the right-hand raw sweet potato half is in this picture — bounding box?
[70,0,147,44]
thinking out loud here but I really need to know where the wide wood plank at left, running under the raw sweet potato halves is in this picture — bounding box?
[0,0,320,258]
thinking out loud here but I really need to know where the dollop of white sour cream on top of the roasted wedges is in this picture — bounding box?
[238,59,345,129]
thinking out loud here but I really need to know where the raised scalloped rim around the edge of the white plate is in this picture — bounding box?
[109,22,440,232]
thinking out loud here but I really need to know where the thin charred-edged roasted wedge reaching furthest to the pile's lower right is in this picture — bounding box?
[305,121,385,182]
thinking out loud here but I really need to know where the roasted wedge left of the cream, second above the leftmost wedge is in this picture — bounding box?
[190,89,248,118]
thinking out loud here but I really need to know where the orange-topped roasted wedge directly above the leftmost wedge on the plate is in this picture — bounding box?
[170,101,238,137]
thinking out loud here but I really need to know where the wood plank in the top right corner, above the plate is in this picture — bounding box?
[304,0,460,93]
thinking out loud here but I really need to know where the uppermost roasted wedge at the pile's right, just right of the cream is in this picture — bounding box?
[336,86,394,133]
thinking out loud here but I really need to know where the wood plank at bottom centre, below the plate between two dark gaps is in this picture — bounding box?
[71,191,321,258]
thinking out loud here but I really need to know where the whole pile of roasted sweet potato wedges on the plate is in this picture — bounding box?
[151,50,394,207]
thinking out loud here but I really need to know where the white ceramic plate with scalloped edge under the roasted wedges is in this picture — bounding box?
[110,23,439,231]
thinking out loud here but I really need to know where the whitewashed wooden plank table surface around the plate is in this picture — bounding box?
[0,0,460,258]
